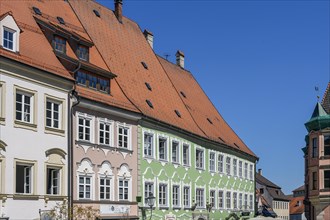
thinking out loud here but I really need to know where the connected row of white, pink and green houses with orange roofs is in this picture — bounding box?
[0,0,258,220]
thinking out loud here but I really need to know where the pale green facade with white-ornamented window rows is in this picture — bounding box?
[138,123,257,220]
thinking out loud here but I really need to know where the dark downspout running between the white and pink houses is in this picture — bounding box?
[68,62,81,219]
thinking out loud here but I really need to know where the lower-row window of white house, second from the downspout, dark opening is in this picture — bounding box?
[16,164,32,194]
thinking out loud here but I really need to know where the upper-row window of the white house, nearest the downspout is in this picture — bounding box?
[46,99,62,129]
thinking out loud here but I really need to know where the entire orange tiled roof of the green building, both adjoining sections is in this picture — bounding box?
[69,0,255,156]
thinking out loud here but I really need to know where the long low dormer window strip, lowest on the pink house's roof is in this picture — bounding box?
[76,71,110,93]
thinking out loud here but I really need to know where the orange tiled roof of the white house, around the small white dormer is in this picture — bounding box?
[0,0,73,80]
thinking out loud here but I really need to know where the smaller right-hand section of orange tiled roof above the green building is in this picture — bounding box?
[159,57,255,156]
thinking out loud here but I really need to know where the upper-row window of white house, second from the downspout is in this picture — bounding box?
[16,91,33,123]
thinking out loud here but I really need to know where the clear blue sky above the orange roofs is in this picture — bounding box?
[98,0,330,194]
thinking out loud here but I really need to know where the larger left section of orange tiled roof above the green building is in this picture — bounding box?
[69,0,206,137]
